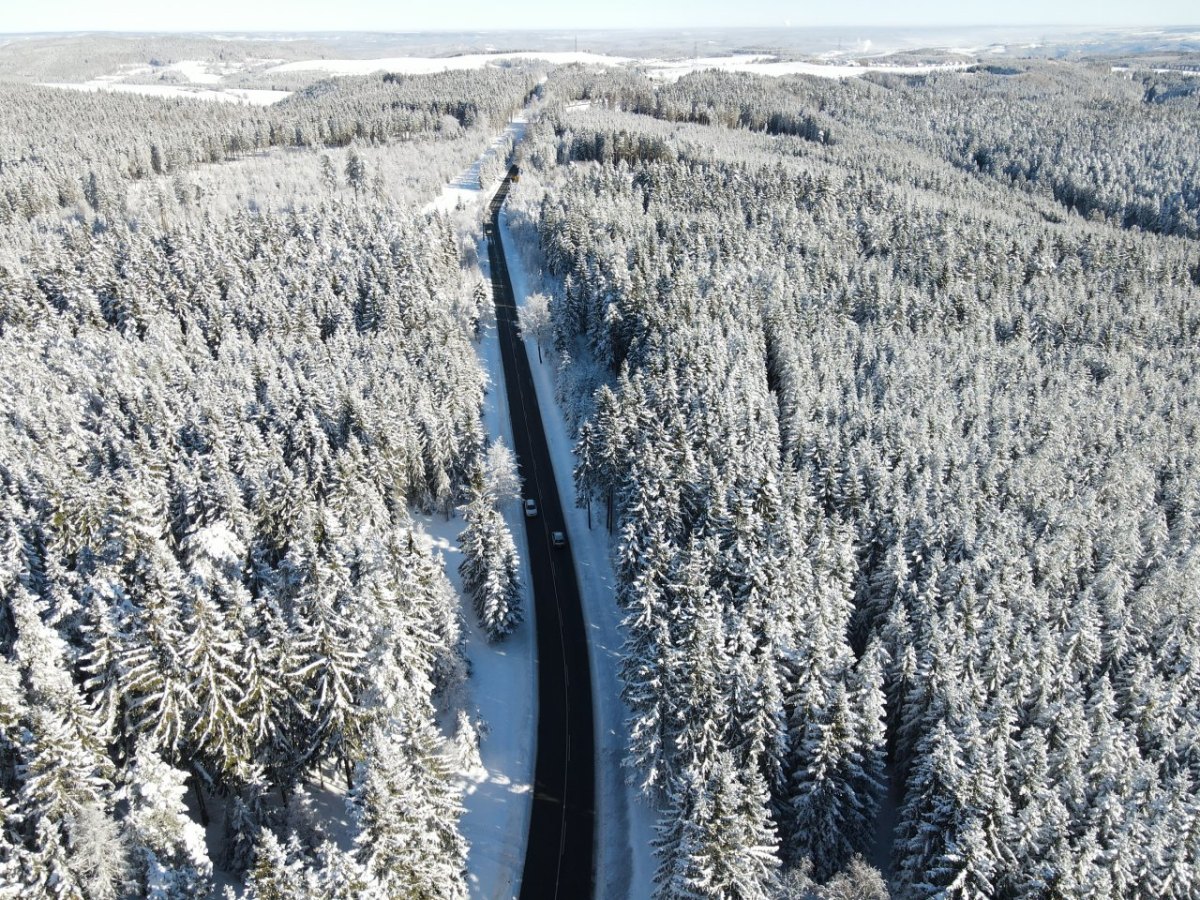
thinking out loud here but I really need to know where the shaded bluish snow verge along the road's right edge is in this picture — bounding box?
[500,211,656,900]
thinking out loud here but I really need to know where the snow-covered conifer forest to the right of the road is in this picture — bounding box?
[510,64,1200,898]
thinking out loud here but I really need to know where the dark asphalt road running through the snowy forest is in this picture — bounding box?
[485,165,595,900]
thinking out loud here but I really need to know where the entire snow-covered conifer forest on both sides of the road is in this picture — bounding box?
[0,28,1200,900]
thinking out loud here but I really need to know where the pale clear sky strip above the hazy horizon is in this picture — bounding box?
[0,0,1200,32]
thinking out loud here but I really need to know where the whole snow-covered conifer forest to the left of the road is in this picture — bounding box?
[0,60,535,899]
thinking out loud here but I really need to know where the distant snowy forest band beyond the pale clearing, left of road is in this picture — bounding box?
[0,68,535,229]
